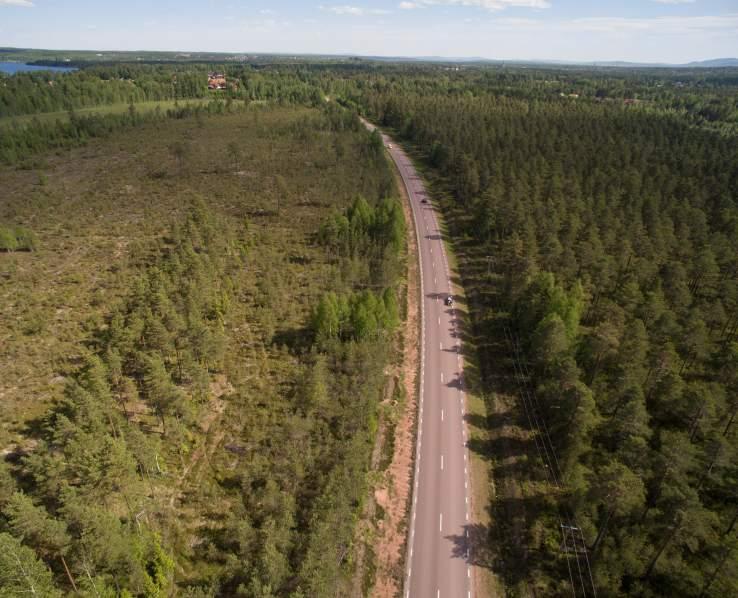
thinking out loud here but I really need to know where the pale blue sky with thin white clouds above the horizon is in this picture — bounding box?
[0,0,738,63]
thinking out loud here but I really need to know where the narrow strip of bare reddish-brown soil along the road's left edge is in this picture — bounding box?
[372,164,420,598]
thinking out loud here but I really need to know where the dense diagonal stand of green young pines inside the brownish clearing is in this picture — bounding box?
[2,203,239,597]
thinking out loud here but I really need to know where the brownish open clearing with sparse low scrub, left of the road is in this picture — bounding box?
[0,106,402,595]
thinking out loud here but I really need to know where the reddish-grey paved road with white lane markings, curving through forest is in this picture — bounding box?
[365,122,472,598]
